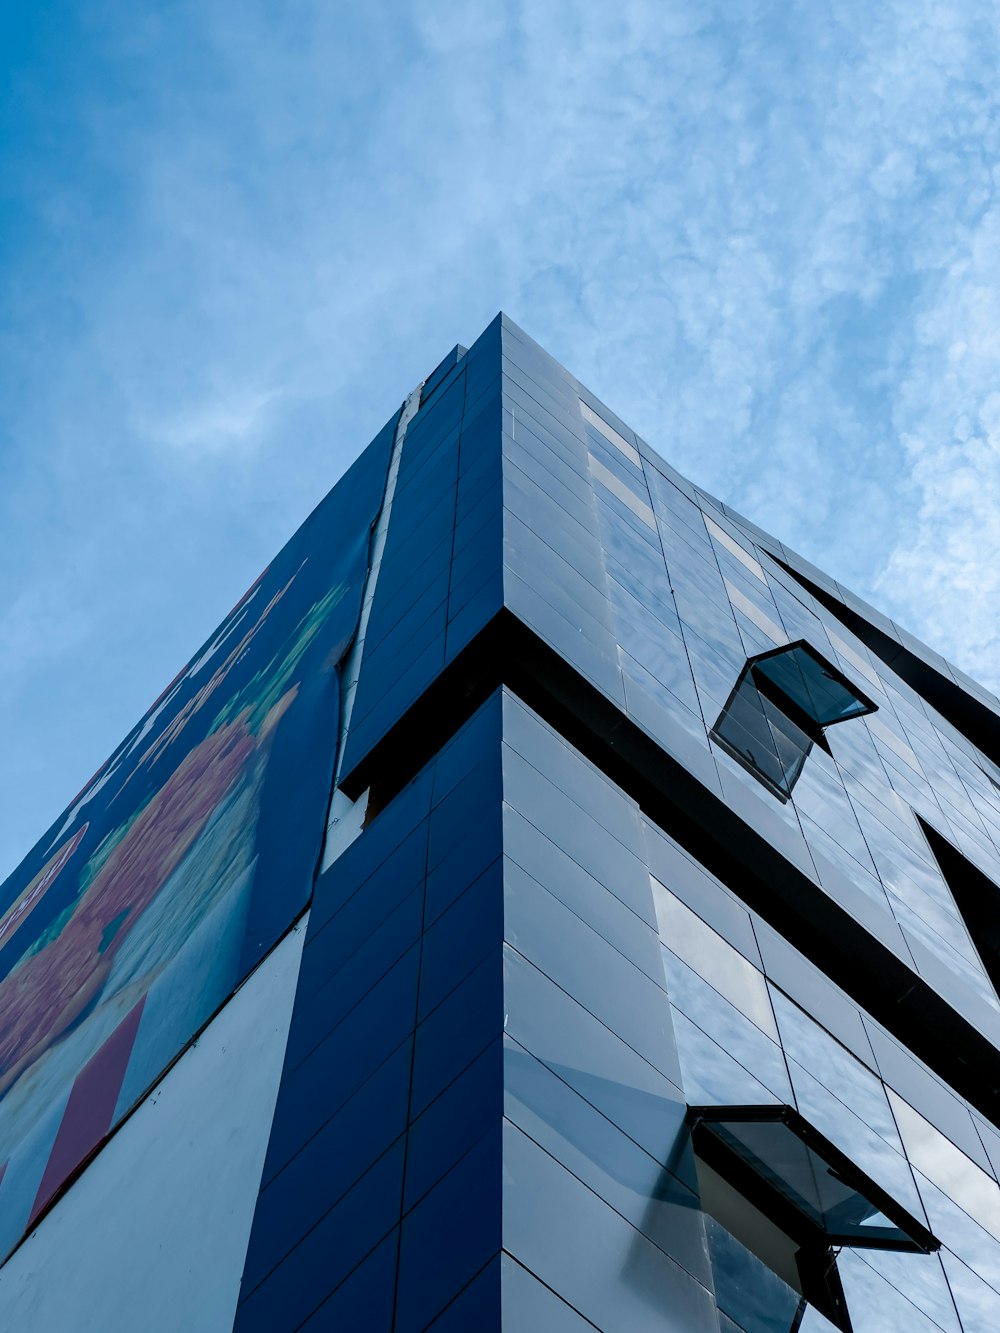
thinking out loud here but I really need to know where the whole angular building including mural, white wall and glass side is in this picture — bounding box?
[0,316,1000,1333]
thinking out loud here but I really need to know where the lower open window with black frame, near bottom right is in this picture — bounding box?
[688,1105,940,1333]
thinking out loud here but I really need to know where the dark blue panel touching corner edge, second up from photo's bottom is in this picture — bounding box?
[396,1124,501,1333]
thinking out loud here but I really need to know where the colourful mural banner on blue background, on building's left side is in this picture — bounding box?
[0,433,388,1256]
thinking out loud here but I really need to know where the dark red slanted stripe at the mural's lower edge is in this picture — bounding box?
[28,996,145,1228]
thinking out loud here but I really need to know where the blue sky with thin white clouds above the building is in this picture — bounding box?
[0,0,1000,877]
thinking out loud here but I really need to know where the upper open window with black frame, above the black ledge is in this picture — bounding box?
[711,640,876,801]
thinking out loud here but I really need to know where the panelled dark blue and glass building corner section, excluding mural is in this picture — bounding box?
[0,316,1000,1333]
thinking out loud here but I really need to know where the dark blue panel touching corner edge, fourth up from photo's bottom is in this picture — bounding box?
[409,949,504,1118]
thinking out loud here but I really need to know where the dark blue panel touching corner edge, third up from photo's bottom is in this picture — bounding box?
[403,1037,504,1209]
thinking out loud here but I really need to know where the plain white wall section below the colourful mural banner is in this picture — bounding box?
[0,918,307,1333]
